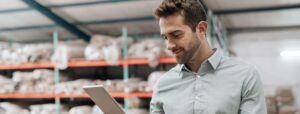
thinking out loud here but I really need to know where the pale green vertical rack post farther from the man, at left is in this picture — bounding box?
[53,32,61,114]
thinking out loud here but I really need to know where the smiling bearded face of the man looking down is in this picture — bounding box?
[159,14,200,64]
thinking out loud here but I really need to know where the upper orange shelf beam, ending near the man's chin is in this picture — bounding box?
[0,57,176,70]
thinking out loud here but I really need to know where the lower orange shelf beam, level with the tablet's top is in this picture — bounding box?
[0,92,152,99]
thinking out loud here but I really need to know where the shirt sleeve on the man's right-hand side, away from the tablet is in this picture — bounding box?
[239,68,267,114]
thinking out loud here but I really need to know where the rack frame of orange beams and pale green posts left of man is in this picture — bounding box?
[0,27,176,114]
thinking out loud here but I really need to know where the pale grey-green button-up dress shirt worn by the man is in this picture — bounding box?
[150,50,267,114]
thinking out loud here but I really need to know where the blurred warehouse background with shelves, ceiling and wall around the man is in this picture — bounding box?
[0,0,300,114]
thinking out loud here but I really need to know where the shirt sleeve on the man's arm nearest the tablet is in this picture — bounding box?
[150,85,165,114]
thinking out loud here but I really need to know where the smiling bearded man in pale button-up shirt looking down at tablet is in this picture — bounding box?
[150,0,267,114]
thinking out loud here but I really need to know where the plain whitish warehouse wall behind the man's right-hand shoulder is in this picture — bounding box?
[229,29,300,104]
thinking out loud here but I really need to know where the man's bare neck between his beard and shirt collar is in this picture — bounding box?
[185,48,214,72]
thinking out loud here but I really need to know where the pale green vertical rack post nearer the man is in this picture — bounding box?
[122,27,129,111]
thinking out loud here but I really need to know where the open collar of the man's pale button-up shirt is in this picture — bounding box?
[180,48,223,78]
